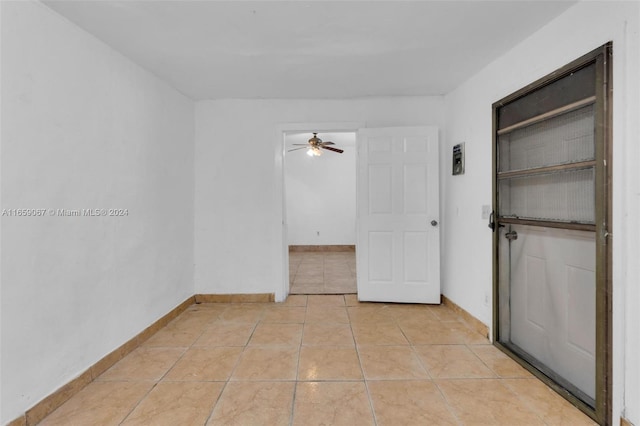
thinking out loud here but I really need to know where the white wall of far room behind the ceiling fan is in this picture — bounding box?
[285,132,356,245]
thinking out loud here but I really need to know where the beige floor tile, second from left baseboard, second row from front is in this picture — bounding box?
[164,346,242,381]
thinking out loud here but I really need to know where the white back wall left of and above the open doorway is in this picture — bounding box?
[195,97,444,298]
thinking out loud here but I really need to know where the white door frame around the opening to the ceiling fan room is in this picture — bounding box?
[275,121,366,302]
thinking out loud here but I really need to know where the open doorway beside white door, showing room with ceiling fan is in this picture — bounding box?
[284,129,357,294]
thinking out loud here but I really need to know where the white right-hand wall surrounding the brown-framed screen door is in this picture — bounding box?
[441,2,640,424]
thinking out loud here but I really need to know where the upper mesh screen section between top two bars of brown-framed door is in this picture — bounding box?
[498,105,594,172]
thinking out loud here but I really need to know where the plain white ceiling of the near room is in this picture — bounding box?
[44,0,575,99]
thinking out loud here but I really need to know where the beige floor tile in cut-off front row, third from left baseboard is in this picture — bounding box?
[207,382,295,426]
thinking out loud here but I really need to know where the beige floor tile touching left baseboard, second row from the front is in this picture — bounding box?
[99,346,186,380]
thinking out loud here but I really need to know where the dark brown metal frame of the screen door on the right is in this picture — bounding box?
[492,42,613,425]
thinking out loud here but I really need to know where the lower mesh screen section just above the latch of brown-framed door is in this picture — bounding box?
[499,168,595,223]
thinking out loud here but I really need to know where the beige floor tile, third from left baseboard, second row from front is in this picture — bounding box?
[231,346,299,380]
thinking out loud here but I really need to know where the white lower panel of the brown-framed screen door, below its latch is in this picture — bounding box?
[504,225,596,398]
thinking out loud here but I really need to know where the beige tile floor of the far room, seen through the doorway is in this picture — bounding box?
[289,251,356,294]
